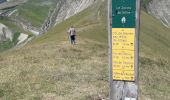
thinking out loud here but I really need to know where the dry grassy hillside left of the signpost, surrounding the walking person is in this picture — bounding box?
[0,0,108,100]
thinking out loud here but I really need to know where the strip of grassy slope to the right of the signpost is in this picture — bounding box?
[140,12,170,100]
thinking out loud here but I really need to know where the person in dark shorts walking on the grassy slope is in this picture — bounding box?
[68,26,76,44]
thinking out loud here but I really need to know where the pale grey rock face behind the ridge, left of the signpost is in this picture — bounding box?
[42,0,95,32]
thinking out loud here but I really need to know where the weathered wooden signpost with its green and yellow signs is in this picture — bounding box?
[108,0,140,100]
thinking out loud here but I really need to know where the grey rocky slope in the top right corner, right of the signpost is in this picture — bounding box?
[148,0,170,28]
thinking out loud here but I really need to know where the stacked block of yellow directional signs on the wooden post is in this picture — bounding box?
[112,28,135,81]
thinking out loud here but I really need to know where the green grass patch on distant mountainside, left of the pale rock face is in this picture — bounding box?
[18,0,55,27]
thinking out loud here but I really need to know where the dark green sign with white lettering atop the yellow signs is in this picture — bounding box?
[112,0,136,28]
